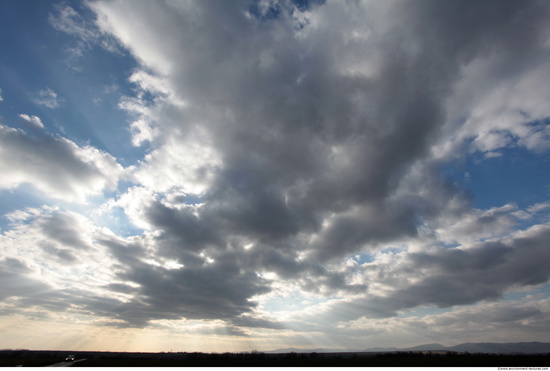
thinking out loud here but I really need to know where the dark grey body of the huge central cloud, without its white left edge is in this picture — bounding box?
[114,1,547,268]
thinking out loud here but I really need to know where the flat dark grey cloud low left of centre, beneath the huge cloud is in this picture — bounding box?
[90,263,269,327]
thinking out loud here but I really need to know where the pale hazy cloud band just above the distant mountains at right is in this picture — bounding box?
[333,297,550,347]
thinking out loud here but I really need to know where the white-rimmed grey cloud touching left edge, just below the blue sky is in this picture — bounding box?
[0,126,123,202]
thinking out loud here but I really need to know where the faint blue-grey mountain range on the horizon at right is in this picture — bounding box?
[265,341,550,354]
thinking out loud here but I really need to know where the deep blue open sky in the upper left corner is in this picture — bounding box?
[1,1,142,164]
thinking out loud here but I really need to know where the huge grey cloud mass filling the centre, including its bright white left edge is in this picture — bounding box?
[80,1,548,320]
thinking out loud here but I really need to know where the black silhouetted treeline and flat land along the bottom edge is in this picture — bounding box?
[0,350,550,367]
